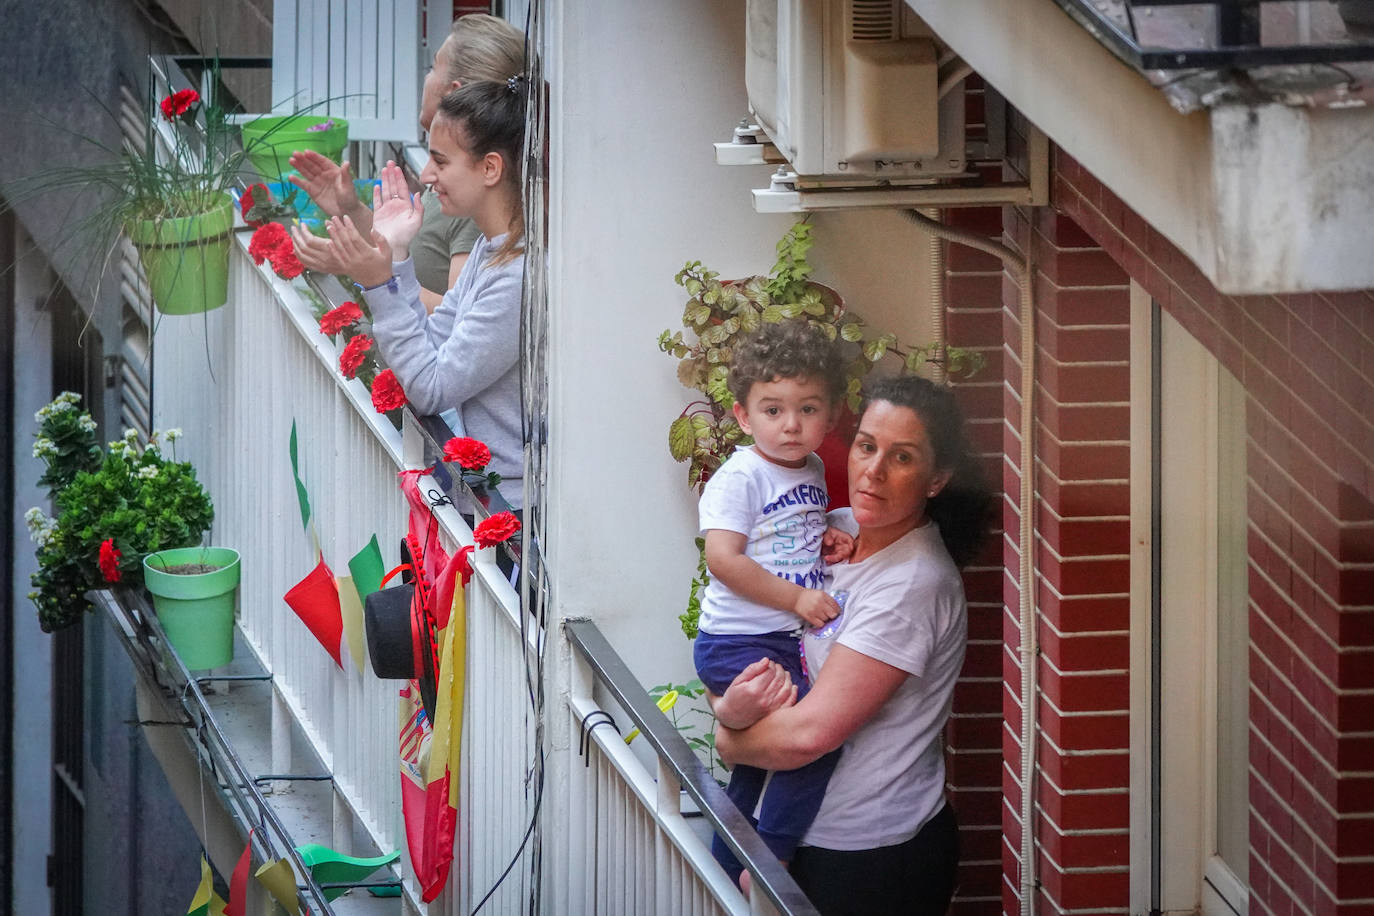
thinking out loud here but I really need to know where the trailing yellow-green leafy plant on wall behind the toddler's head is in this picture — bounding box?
[658,222,982,494]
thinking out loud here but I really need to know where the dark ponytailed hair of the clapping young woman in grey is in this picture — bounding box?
[438,77,525,264]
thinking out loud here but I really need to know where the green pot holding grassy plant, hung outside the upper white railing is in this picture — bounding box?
[125,194,234,314]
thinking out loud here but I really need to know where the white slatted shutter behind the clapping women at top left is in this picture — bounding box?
[272,0,423,141]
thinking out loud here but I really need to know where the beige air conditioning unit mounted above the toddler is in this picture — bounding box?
[745,0,966,181]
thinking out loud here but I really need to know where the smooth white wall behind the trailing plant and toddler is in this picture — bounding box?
[545,0,925,685]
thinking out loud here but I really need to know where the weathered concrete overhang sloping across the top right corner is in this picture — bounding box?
[907,0,1374,294]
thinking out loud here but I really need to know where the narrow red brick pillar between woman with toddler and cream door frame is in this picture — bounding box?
[1003,197,1131,913]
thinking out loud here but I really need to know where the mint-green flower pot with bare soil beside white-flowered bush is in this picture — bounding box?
[143,547,239,670]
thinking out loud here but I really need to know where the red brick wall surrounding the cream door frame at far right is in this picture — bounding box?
[1038,146,1374,913]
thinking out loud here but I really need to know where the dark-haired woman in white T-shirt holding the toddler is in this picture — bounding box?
[716,376,991,915]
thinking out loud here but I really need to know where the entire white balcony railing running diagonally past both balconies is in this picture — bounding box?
[135,51,813,915]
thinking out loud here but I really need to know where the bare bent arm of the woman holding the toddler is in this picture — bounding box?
[716,645,911,769]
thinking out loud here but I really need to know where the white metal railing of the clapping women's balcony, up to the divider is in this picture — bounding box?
[153,235,534,913]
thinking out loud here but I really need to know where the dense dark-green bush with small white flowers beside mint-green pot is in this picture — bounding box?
[25,391,214,633]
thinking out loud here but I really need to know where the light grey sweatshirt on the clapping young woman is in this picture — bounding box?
[367,236,525,505]
